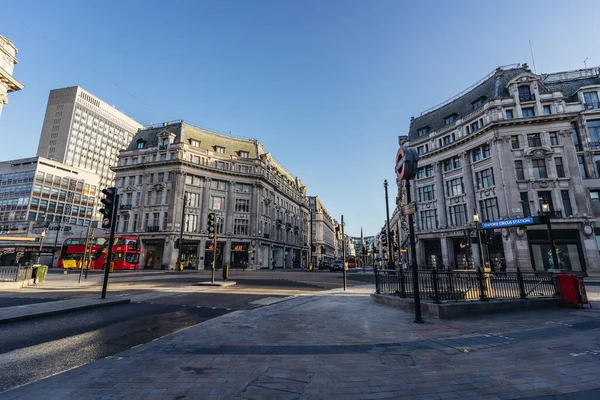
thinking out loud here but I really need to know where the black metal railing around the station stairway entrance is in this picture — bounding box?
[375,269,559,303]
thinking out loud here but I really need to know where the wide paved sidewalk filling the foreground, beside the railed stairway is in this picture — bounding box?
[0,286,600,400]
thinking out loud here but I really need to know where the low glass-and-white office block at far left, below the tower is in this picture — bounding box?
[0,157,98,265]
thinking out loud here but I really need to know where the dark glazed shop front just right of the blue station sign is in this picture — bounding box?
[527,229,586,273]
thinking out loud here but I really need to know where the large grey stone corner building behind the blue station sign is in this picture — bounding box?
[399,64,600,274]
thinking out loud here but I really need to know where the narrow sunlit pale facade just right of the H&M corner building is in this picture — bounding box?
[308,196,341,266]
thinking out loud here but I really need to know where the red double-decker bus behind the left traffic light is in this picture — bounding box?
[58,236,141,270]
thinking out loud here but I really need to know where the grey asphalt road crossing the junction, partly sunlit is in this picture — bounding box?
[0,272,373,393]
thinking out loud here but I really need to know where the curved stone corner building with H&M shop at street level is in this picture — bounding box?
[114,121,309,269]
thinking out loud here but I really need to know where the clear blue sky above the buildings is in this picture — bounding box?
[0,0,600,236]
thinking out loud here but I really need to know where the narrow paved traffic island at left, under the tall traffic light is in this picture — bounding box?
[0,297,130,324]
